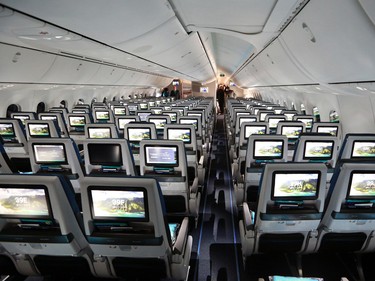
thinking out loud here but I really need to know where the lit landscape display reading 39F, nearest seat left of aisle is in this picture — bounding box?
[91,190,146,219]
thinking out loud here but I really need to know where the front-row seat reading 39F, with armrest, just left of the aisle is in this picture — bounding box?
[82,176,192,280]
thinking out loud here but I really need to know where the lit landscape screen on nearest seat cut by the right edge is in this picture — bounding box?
[349,173,375,198]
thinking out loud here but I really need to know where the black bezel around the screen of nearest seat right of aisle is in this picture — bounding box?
[271,170,322,201]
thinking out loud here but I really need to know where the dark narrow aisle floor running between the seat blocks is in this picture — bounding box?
[189,115,243,281]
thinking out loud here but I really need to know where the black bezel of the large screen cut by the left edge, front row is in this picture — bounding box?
[0,184,53,220]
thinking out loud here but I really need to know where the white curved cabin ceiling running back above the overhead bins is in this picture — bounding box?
[0,0,305,82]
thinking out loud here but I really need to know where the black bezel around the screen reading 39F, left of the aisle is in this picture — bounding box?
[87,185,150,222]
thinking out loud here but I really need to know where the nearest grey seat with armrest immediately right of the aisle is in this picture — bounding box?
[239,163,327,259]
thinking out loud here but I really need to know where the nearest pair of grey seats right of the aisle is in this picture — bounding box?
[239,160,375,260]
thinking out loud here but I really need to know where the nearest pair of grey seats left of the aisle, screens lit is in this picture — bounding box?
[0,174,192,280]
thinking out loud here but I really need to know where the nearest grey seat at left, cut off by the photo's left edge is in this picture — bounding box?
[0,174,93,278]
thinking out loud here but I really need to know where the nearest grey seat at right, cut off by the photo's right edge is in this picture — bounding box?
[317,160,375,253]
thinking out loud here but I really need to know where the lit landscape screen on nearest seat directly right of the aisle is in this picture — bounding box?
[273,173,319,198]
